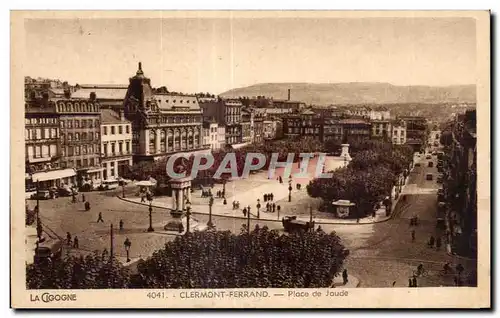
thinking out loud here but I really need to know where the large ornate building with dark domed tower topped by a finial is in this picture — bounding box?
[124,63,207,161]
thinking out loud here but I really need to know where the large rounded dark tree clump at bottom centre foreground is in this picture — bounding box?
[130,226,346,288]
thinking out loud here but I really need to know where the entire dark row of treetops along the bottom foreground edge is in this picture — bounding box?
[27,225,346,289]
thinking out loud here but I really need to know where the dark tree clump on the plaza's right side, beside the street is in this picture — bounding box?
[307,140,413,218]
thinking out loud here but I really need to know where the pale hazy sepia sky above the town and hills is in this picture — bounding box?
[24,18,476,94]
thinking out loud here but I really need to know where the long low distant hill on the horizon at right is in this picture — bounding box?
[219,83,476,105]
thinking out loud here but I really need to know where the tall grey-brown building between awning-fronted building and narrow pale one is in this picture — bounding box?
[54,98,103,186]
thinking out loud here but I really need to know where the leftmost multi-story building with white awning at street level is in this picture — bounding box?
[24,93,76,189]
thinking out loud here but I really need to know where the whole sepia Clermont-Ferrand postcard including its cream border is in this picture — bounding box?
[10,11,491,308]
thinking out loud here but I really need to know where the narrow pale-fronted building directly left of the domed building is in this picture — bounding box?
[101,109,132,180]
